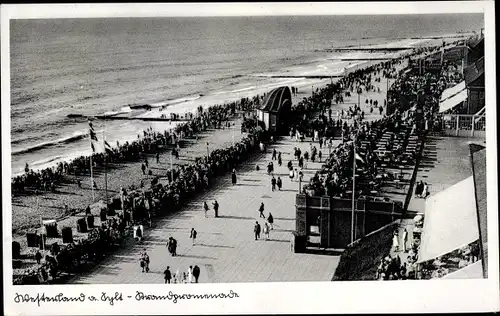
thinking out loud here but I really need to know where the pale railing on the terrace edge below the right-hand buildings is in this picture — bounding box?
[441,114,486,137]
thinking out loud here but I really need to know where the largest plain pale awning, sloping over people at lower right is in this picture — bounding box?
[419,176,479,262]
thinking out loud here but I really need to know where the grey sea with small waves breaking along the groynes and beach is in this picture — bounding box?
[10,14,483,174]
